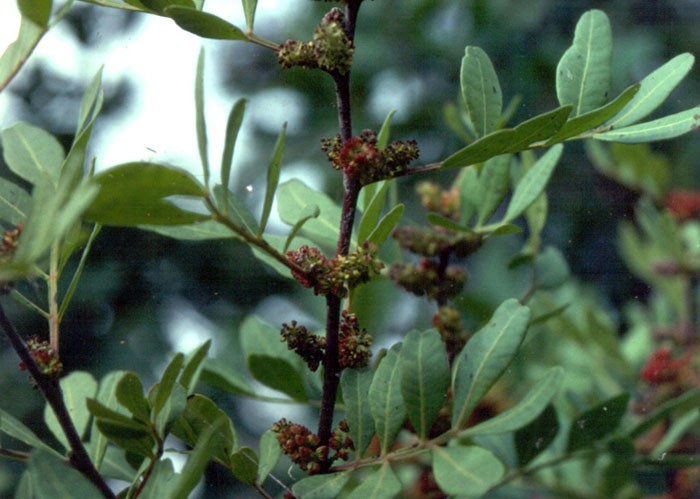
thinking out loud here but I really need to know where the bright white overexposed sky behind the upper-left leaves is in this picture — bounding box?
[0,0,305,180]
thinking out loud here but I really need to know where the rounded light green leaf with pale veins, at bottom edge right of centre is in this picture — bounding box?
[432,446,505,497]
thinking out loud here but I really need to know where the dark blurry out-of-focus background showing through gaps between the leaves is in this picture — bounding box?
[0,0,700,497]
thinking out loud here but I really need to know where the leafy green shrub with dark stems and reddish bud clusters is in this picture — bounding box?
[0,0,700,499]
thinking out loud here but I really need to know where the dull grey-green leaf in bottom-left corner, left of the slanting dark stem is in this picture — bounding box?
[27,450,102,499]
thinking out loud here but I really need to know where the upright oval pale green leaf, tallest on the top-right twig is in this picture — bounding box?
[557,9,612,116]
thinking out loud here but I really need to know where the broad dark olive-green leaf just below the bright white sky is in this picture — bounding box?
[85,162,209,227]
